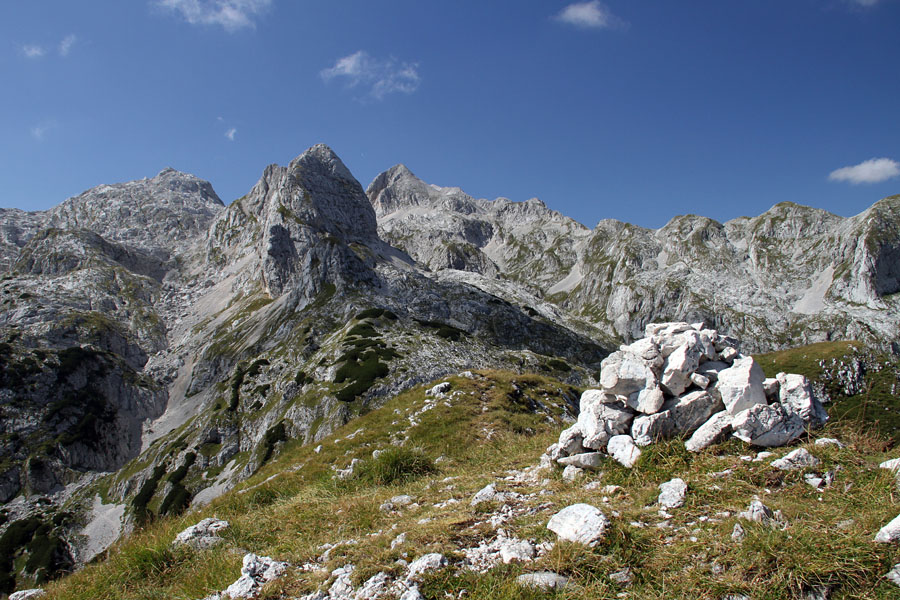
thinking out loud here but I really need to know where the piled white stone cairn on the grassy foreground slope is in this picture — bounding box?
[544,323,828,469]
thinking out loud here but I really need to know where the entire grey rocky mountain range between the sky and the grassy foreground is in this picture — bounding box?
[0,145,900,592]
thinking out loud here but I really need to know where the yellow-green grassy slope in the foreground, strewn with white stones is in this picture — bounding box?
[47,350,900,599]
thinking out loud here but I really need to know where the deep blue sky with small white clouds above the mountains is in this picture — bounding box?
[0,0,900,227]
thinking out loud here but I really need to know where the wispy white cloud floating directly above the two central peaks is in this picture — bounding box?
[320,50,422,100]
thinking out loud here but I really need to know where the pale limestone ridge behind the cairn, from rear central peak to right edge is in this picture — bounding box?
[368,166,900,351]
